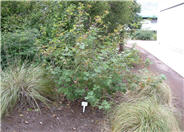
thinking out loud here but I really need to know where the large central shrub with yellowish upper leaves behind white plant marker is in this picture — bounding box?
[37,3,139,109]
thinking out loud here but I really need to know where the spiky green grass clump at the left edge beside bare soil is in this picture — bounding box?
[1,64,53,116]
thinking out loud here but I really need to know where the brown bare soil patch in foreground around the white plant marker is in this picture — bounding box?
[1,102,104,132]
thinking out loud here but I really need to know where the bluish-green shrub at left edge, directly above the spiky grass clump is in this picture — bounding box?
[1,29,39,68]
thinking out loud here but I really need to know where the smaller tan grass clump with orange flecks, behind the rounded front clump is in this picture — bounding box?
[126,70,172,106]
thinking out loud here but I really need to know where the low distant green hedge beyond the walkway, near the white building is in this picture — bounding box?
[132,30,156,40]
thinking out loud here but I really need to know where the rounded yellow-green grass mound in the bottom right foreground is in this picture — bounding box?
[111,99,179,132]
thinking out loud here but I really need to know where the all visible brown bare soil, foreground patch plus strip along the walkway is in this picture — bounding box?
[1,44,184,132]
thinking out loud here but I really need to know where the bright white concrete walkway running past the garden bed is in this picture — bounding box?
[128,40,184,77]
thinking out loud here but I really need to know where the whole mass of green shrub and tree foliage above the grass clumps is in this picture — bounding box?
[1,1,140,109]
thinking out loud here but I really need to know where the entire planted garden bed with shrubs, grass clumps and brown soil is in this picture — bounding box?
[0,1,182,132]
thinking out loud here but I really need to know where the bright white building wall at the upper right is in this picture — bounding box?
[158,3,184,55]
